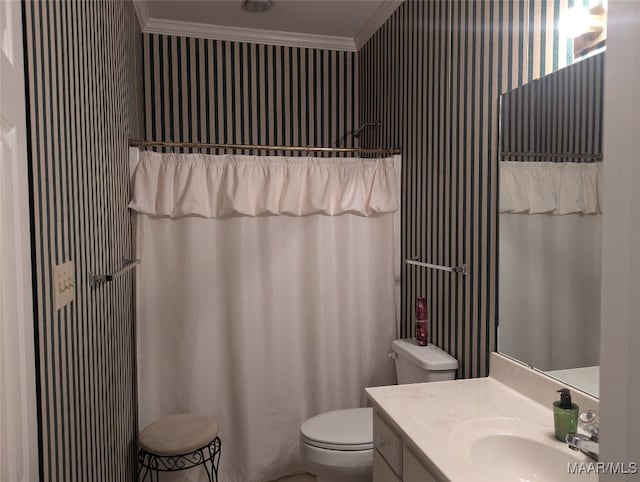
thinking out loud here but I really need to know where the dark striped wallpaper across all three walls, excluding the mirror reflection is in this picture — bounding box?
[15,0,596,482]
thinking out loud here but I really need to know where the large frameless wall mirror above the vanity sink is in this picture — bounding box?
[498,53,606,396]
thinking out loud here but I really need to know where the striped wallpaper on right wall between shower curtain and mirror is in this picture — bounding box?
[359,0,572,378]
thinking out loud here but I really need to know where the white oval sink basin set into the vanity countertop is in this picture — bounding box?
[449,417,598,482]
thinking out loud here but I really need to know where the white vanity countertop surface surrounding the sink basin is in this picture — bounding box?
[366,358,589,482]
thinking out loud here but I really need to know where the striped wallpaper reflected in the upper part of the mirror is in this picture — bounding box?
[500,53,605,162]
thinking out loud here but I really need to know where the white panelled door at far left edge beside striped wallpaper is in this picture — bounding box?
[0,2,40,482]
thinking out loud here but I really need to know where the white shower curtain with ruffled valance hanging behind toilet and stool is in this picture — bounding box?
[131,153,399,482]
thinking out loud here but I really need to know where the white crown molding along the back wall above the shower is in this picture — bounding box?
[142,17,358,52]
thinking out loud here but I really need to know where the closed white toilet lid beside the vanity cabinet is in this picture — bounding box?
[300,408,373,450]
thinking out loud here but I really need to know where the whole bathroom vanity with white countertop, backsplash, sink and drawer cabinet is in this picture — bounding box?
[366,353,599,482]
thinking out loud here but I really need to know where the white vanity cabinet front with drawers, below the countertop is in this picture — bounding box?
[373,409,442,482]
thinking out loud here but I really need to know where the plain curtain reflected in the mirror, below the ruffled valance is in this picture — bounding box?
[498,213,601,370]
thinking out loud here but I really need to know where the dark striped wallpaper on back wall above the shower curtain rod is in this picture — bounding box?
[143,34,359,155]
